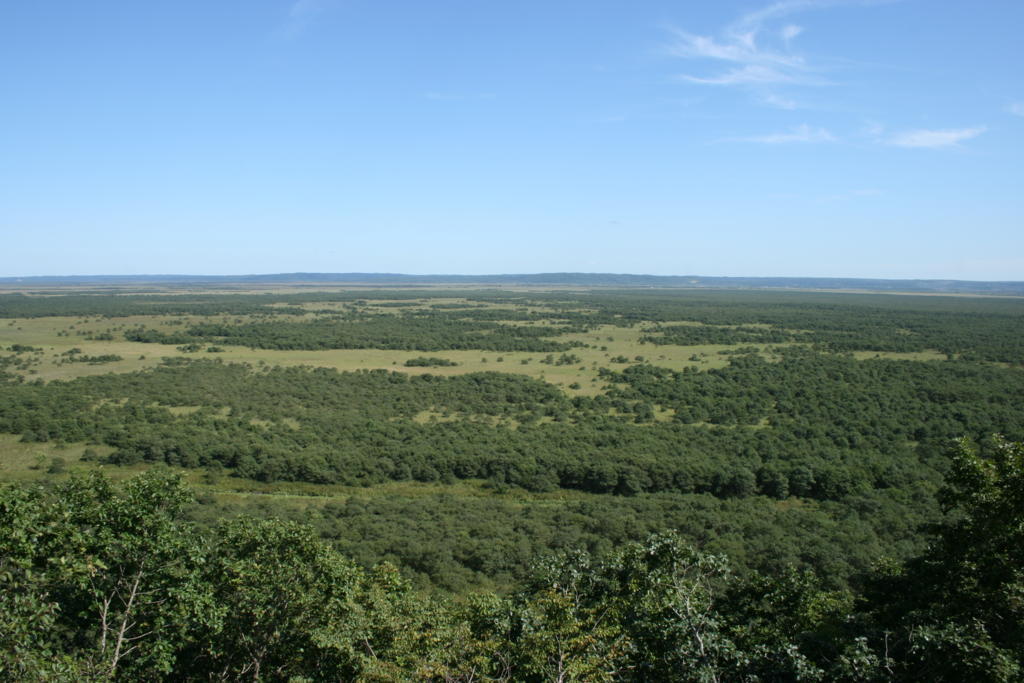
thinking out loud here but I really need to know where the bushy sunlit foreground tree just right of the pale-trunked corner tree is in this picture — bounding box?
[185,519,468,681]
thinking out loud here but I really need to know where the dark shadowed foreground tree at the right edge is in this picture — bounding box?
[868,438,1024,681]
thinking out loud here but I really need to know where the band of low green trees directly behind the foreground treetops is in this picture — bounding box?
[218,483,933,594]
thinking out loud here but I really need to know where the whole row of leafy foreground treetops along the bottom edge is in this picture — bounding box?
[0,454,1024,682]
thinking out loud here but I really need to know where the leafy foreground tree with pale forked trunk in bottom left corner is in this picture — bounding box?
[0,472,210,679]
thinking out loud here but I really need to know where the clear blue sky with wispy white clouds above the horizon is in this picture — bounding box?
[0,0,1024,280]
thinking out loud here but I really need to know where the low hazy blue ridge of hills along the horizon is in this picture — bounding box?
[0,272,1024,296]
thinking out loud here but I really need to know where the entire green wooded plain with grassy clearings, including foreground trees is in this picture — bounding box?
[0,288,1024,681]
